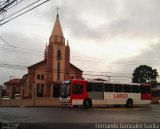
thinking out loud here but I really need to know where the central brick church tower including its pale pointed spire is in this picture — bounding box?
[47,12,69,82]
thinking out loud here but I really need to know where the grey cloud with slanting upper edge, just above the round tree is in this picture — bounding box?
[111,42,160,78]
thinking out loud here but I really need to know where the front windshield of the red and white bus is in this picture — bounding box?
[60,82,70,98]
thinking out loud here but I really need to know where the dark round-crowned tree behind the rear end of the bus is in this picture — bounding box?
[132,65,159,84]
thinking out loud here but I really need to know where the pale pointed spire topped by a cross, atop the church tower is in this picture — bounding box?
[50,8,64,43]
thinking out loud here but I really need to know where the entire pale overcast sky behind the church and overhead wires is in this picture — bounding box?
[0,0,160,84]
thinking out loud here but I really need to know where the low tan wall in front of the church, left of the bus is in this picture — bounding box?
[0,98,60,107]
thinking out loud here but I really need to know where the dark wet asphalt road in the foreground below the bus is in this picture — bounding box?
[0,105,160,129]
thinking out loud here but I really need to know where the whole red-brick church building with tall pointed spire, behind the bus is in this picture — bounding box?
[21,14,83,98]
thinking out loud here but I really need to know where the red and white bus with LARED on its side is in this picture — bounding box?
[60,80,152,108]
